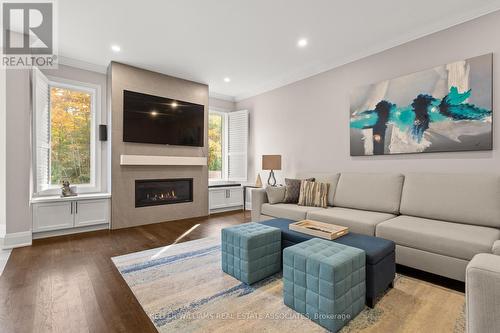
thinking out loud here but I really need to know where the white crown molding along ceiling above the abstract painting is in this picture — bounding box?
[234,4,500,102]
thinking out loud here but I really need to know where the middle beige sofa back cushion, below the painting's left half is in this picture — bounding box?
[333,173,404,214]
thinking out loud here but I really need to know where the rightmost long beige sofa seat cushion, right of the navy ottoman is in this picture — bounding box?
[377,215,500,260]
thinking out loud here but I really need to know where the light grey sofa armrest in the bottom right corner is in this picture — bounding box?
[465,253,500,333]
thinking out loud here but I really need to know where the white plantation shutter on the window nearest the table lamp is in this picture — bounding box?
[227,110,248,181]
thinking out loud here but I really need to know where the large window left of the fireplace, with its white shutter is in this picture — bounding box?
[33,69,100,195]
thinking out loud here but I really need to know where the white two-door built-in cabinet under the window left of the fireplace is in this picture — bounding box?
[32,196,110,233]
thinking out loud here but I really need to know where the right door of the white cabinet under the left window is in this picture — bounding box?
[74,199,109,227]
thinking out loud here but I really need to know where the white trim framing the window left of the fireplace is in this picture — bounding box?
[33,75,102,197]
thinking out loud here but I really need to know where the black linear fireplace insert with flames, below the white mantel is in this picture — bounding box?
[135,178,193,207]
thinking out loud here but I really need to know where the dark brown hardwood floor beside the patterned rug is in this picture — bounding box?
[0,212,250,333]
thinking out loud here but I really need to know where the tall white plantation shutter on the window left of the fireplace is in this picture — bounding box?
[32,68,50,193]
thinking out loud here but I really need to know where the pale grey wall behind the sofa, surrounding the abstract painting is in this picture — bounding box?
[236,12,500,183]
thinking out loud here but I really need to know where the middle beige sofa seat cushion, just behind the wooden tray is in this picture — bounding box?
[307,207,395,236]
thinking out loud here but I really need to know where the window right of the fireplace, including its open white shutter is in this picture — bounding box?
[208,110,248,181]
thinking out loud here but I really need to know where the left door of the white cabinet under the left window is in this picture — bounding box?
[33,201,73,232]
